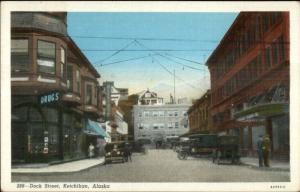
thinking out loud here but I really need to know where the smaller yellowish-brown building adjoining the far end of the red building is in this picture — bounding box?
[187,90,213,133]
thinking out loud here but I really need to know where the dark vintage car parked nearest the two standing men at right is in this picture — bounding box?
[213,135,240,164]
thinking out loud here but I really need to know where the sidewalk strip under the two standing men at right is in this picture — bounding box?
[241,157,290,171]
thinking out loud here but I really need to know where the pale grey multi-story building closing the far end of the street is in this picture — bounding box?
[133,104,190,141]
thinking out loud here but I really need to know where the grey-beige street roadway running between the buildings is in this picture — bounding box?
[12,149,290,182]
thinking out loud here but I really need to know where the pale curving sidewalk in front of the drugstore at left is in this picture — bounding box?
[11,157,104,173]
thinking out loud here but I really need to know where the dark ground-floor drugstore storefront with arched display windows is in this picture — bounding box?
[11,96,86,163]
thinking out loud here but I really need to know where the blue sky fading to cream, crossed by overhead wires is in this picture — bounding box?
[68,12,238,101]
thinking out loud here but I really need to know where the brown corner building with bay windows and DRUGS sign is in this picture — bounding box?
[11,12,105,162]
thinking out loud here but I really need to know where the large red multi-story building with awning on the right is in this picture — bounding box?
[206,12,290,158]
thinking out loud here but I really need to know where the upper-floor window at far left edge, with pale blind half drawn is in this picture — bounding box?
[11,39,29,72]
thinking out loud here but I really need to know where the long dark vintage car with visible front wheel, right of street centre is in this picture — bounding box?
[177,134,217,160]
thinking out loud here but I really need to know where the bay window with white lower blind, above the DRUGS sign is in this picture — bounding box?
[37,40,55,74]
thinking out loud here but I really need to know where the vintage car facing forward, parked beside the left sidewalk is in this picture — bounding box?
[105,142,125,164]
